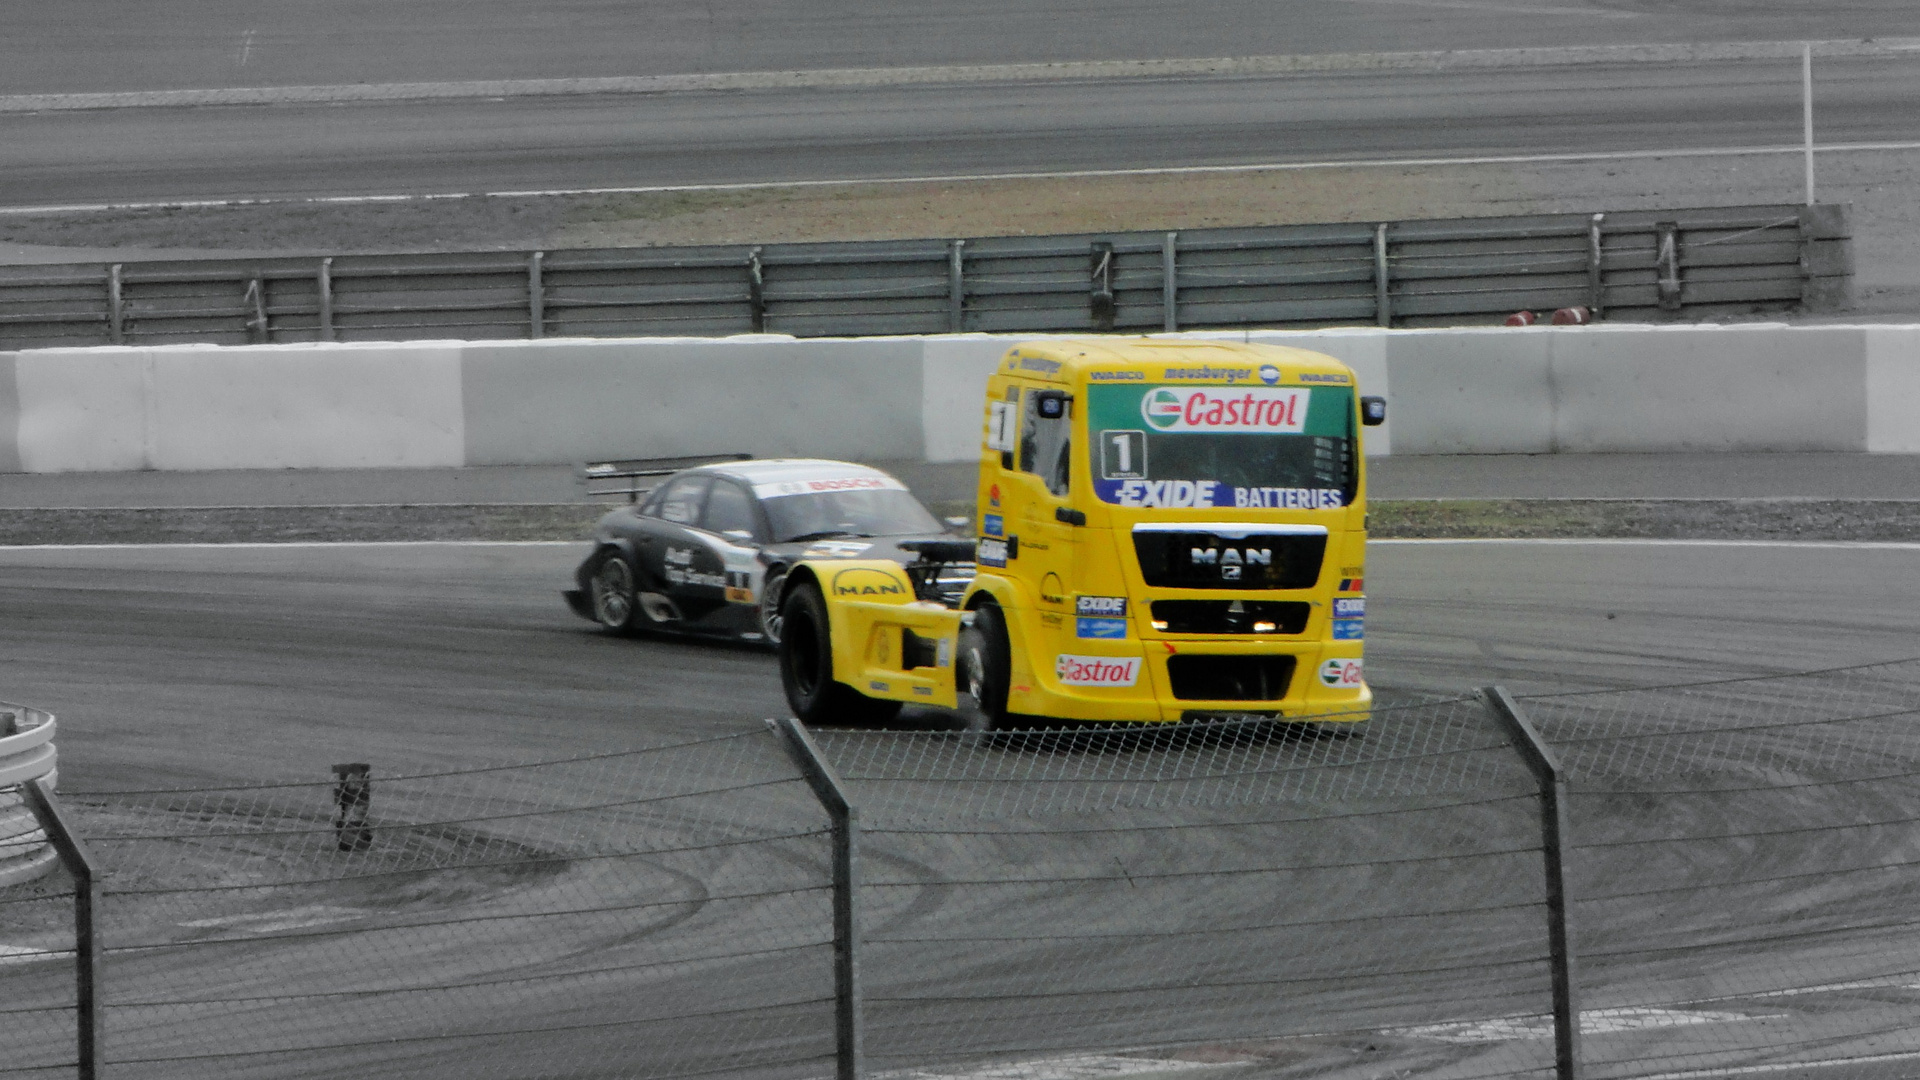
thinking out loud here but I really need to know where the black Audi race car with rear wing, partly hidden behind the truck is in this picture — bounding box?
[566,459,973,644]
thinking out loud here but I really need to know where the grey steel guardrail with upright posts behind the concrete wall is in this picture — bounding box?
[0,204,1853,348]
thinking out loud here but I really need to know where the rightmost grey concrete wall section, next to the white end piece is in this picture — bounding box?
[1551,325,1866,454]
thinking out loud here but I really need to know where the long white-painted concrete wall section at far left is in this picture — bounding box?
[15,346,463,473]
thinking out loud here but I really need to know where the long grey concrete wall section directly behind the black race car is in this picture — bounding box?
[461,338,925,465]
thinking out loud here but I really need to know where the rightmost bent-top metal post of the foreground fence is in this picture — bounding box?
[1480,686,1580,1080]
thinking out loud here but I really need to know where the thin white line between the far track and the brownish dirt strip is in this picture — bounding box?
[0,140,1920,215]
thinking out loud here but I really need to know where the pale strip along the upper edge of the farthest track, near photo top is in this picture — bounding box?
[0,36,1920,113]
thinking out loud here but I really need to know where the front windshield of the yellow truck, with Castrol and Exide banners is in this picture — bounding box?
[1087,382,1357,509]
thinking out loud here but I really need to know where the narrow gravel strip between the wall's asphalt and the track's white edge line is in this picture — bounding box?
[0,498,1920,546]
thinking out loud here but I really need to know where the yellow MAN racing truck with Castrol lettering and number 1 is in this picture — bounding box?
[780,338,1386,728]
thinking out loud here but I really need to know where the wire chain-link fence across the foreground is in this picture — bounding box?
[11,661,1920,1080]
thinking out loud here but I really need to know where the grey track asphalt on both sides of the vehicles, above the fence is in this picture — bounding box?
[0,542,1920,790]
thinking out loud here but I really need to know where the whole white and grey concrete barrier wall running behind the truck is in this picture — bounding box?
[0,325,1920,473]
